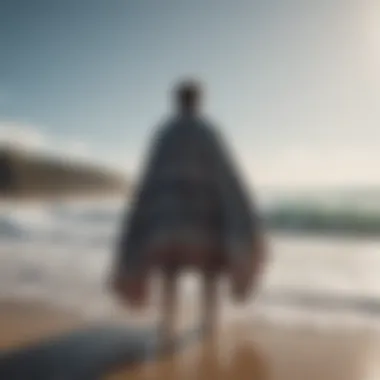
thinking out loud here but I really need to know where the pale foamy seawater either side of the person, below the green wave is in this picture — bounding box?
[0,200,380,329]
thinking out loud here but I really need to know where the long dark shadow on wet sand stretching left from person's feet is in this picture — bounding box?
[0,326,200,380]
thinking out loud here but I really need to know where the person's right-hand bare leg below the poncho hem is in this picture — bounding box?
[202,271,218,335]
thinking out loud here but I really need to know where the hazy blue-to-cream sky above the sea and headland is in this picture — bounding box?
[0,0,380,190]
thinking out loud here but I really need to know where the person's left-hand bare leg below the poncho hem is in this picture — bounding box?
[162,268,178,349]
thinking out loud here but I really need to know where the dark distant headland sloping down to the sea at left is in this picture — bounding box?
[0,146,128,199]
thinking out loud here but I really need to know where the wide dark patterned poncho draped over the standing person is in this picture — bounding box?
[111,115,258,302]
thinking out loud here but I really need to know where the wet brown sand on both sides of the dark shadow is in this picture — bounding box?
[0,302,380,380]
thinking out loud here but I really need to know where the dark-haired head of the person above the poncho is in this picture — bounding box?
[174,80,202,113]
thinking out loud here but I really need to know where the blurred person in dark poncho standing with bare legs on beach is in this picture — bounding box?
[113,80,265,342]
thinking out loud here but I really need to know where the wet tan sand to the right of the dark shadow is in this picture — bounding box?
[107,324,379,380]
